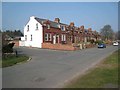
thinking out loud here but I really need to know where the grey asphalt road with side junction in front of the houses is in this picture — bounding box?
[2,46,118,88]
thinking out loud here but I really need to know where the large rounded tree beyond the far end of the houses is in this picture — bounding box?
[101,25,113,40]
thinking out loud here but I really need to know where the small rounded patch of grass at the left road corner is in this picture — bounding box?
[2,55,29,67]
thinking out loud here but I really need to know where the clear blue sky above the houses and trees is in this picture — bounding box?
[2,2,118,31]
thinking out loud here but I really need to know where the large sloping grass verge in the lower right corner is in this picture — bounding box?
[65,50,120,88]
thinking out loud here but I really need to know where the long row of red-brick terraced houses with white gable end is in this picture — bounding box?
[21,16,101,50]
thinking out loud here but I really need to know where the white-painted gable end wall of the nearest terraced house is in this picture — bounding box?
[24,16,43,48]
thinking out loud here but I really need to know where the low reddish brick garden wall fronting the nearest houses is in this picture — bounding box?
[42,43,79,51]
